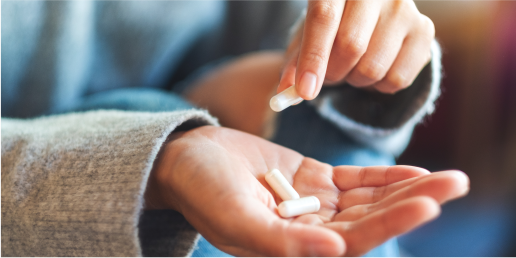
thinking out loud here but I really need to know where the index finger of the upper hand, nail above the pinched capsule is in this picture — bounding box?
[296,0,346,100]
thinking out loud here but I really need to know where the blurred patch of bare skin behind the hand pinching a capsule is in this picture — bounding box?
[186,51,285,138]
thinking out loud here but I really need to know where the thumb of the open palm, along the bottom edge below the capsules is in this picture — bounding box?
[212,198,345,257]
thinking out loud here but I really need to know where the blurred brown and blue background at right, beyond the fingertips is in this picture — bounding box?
[398,0,516,257]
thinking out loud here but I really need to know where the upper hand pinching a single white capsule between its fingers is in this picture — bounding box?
[277,0,435,100]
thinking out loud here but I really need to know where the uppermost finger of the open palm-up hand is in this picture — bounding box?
[333,166,430,191]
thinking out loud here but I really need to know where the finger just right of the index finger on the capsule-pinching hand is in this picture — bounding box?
[326,0,382,82]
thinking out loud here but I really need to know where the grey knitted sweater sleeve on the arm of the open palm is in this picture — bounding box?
[0,109,217,257]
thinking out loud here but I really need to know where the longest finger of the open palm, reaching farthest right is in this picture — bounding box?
[334,171,469,221]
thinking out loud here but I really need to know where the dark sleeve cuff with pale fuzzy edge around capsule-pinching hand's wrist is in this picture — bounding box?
[310,40,441,156]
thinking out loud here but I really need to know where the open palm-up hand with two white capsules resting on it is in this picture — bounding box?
[145,126,469,257]
